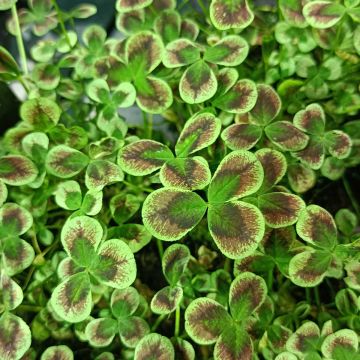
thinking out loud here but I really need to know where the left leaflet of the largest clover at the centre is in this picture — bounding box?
[142,188,206,241]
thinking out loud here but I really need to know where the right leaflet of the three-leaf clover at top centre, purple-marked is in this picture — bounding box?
[204,35,249,66]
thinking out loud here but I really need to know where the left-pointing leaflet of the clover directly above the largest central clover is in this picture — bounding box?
[118,140,174,176]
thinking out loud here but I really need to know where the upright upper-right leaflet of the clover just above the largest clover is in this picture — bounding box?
[175,112,221,157]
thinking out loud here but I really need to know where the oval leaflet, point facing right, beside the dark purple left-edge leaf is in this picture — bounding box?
[45,145,89,179]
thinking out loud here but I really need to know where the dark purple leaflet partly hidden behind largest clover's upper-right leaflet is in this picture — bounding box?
[255,148,287,192]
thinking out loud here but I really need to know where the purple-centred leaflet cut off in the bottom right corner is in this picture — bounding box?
[321,329,359,359]
